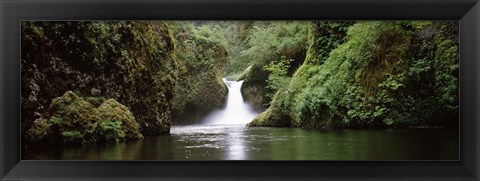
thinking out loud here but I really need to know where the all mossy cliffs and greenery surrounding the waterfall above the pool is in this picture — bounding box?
[21,21,459,146]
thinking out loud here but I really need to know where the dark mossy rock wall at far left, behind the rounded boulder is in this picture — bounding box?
[21,21,176,135]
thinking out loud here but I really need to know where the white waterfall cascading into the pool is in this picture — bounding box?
[205,78,257,124]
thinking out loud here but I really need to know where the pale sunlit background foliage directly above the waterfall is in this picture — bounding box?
[218,21,309,78]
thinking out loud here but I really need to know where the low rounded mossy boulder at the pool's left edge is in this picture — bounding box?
[26,91,143,144]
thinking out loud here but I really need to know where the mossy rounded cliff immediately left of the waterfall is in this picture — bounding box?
[170,22,227,124]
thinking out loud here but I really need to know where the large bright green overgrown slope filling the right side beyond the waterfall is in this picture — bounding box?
[249,22,459,128]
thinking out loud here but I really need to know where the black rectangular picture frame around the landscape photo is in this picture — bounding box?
[0,0,480,181]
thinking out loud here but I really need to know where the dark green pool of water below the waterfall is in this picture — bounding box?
[22,125,459,160]
